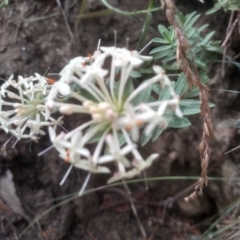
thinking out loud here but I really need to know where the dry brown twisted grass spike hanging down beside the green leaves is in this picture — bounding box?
[162,0,213,200]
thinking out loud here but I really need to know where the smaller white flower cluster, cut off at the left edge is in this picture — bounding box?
[0,73,61,141]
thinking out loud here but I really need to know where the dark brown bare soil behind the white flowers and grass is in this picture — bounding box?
[0,0,240,240]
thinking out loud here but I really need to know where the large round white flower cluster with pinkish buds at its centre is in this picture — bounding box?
[44,47,182,186]
